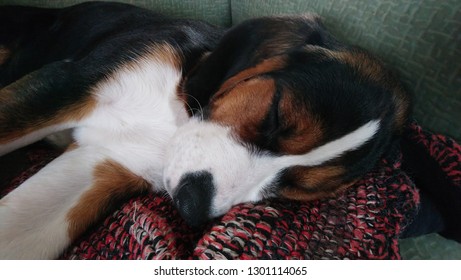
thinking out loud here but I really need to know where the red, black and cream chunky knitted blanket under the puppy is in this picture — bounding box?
[0,123,461,259]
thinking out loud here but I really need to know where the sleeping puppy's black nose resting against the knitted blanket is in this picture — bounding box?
[173,171,214,227]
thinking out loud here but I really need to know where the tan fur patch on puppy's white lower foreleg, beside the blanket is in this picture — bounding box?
[67,160,150,240]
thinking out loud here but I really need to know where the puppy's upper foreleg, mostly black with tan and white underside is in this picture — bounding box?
[0,61,95,156]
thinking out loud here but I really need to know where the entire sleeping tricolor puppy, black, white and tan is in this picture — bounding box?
[0,3,408,258]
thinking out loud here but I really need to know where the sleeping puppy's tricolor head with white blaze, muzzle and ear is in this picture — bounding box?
[164,15,408,225]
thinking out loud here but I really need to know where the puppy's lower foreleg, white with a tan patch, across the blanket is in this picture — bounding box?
[0,147,149,259]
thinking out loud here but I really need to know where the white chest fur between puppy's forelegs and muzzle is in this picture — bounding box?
[74,58,187,189]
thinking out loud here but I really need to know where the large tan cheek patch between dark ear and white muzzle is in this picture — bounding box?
[210,79,275,142]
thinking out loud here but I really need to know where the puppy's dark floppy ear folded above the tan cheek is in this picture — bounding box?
[184,15,325,113]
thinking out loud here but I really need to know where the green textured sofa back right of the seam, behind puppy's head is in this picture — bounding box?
[231,0,461,140]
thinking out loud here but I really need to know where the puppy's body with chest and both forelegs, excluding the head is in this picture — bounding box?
[0,3,219,258]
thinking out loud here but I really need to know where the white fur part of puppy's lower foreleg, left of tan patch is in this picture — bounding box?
[0,147,105,259]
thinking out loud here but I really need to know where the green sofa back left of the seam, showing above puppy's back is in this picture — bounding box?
[0,0,231,26]
